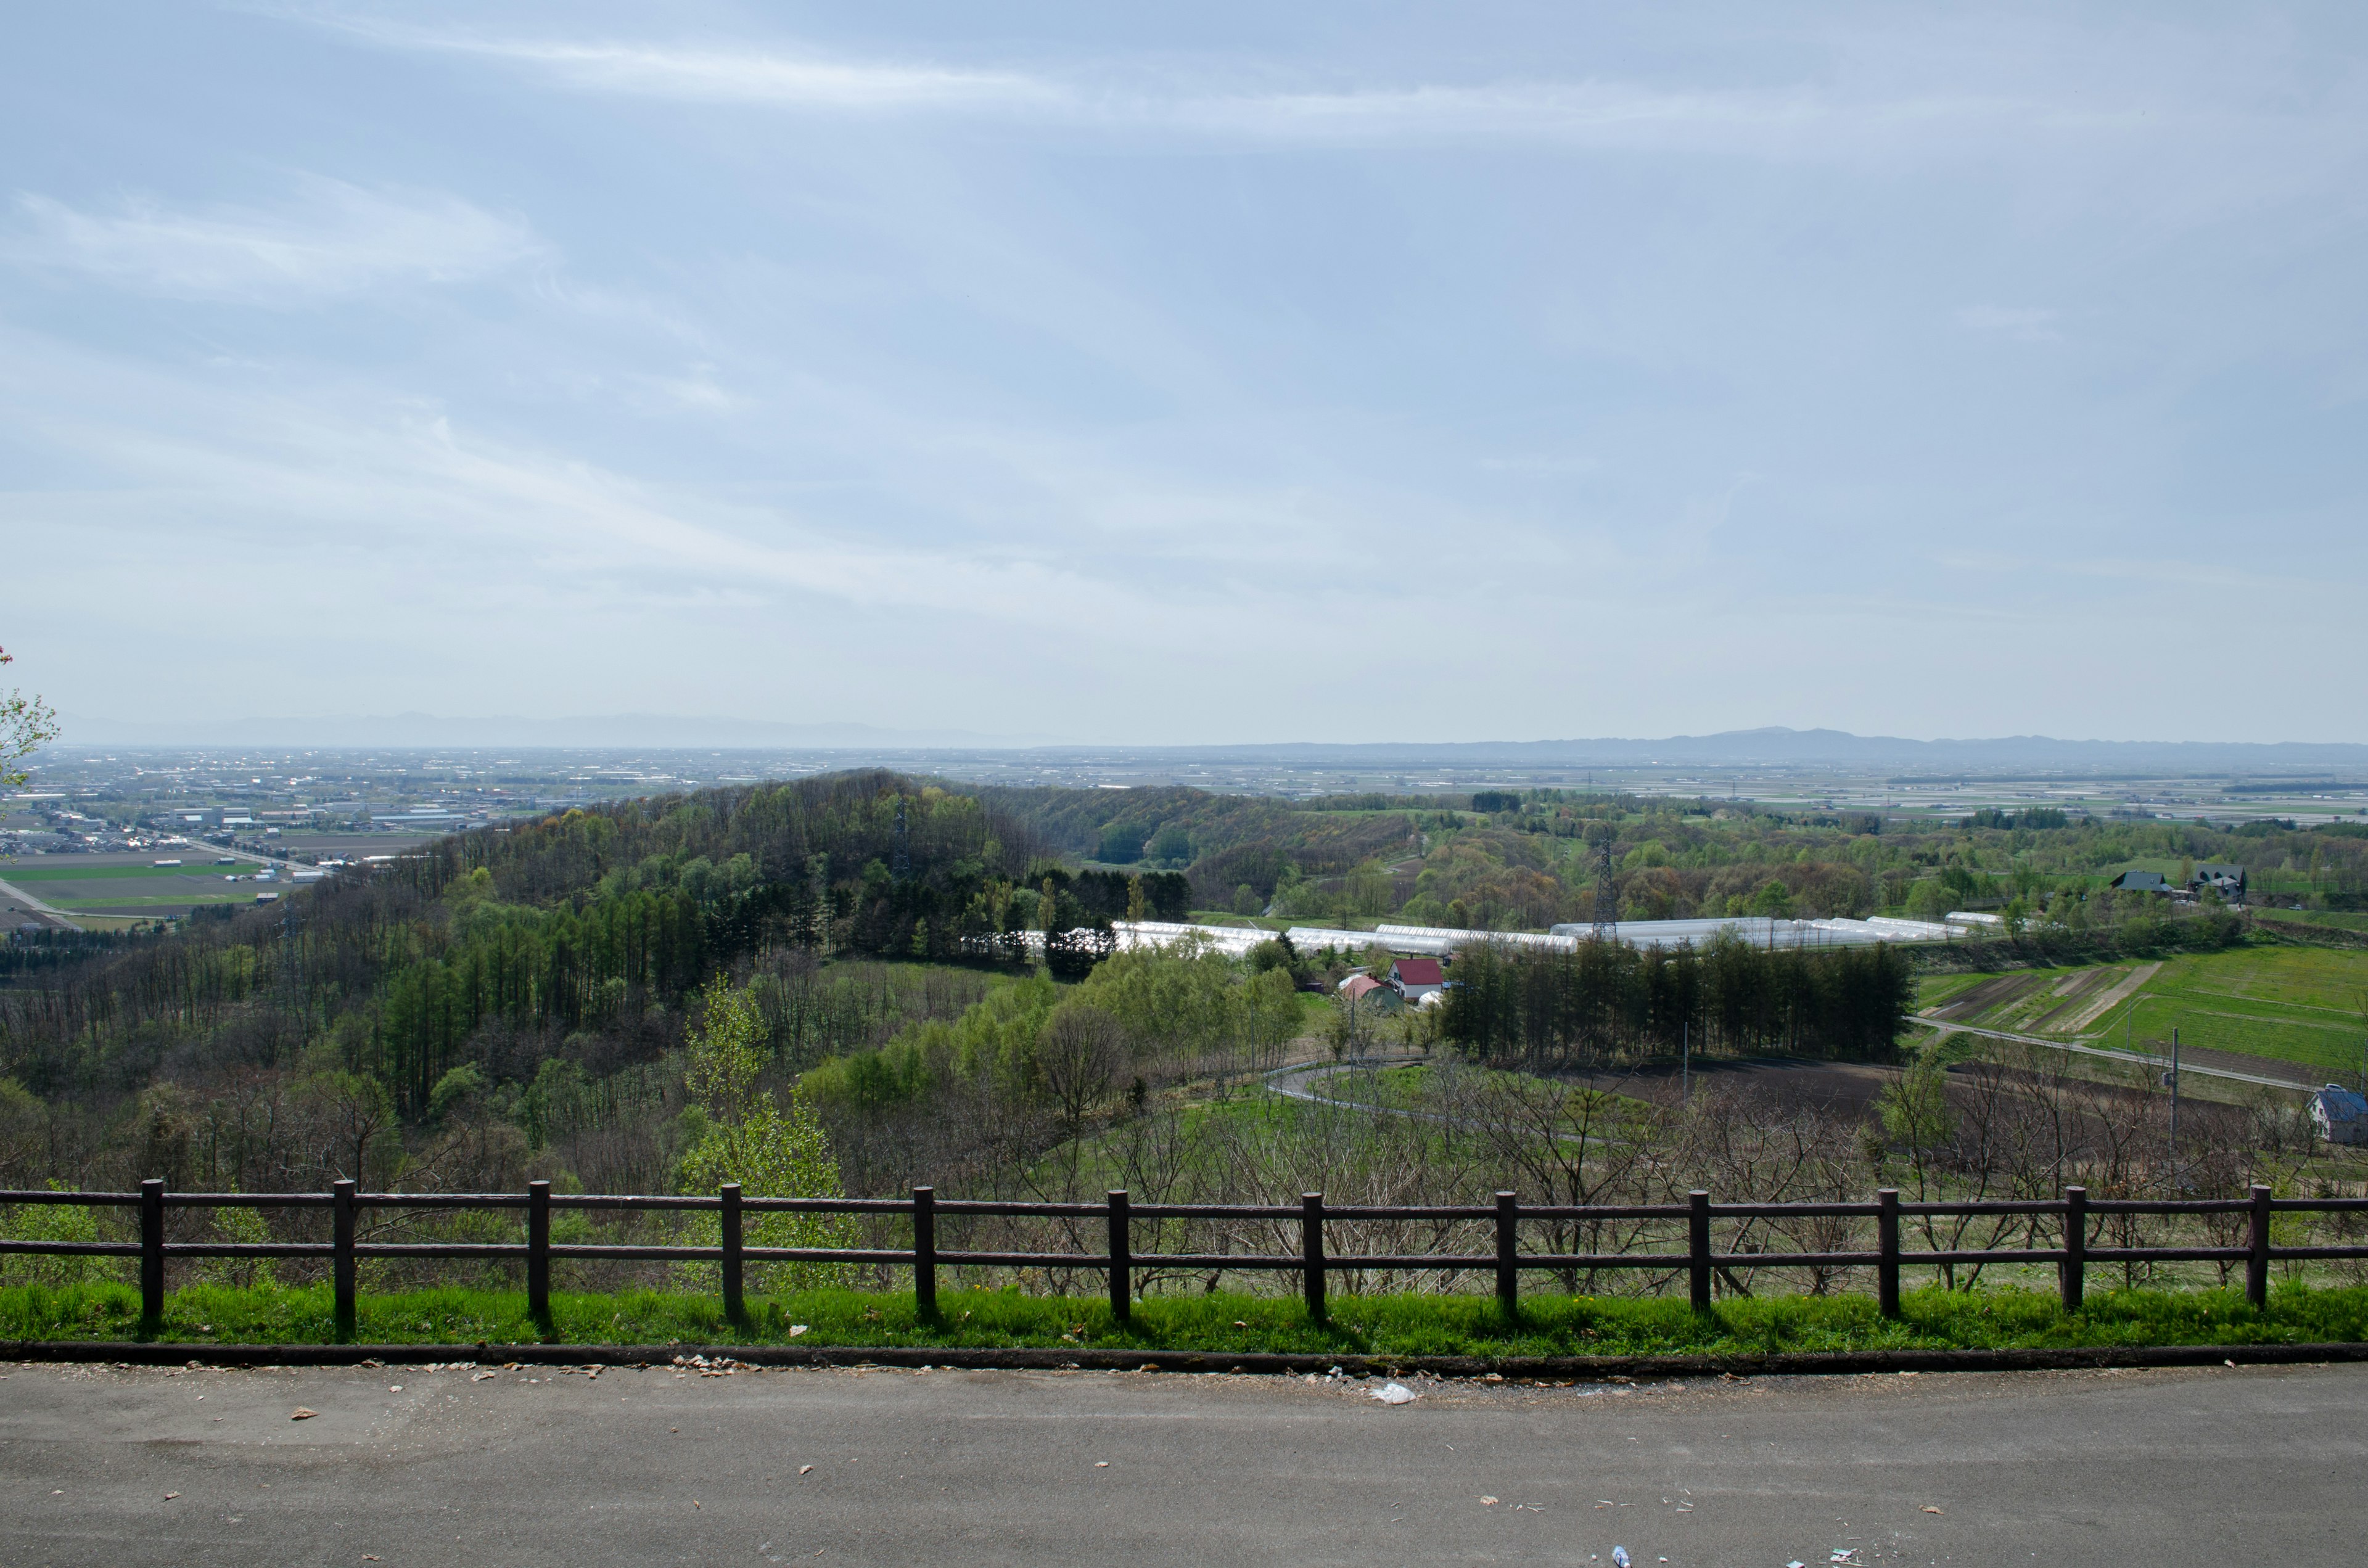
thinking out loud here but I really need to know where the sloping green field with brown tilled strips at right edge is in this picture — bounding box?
[1916,945,2368,1073]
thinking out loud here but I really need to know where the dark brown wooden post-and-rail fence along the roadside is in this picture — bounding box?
[0,1180,2368,1331]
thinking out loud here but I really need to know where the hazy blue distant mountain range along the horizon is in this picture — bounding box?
[46,713,2368,777]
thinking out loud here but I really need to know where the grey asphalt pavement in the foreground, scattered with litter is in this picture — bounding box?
[0,1365,2368,1568]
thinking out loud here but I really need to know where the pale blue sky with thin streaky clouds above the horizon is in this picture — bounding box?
[0,0,2368,744]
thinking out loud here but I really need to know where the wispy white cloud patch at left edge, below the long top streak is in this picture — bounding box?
[0,178,538,303]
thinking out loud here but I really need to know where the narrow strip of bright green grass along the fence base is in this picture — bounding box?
[0,1284,2368,1355]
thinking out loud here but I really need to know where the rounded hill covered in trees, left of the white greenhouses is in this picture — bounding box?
[0,772,1084,1115]
